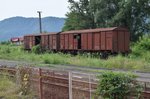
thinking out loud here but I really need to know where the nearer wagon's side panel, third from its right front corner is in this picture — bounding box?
[93,33,100,50]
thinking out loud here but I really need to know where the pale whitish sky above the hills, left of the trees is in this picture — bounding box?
[0,0,69,20]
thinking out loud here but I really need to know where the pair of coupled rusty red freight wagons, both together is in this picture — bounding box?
[24,27,130,57]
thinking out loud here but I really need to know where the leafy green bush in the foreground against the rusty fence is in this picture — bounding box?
[97,72,141,99]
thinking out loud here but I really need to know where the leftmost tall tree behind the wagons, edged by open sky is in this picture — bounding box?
[63,0,95,31]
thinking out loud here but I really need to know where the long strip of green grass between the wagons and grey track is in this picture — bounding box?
[0,45,150,71]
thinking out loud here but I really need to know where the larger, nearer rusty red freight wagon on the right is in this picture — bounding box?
[60,27,130,53]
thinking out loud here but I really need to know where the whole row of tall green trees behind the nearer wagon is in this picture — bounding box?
[63,0,150,41]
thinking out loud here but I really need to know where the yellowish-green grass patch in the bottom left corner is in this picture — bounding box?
[0,70,35,99]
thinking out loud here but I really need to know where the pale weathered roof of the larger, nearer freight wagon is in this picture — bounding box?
[61,27,128,34]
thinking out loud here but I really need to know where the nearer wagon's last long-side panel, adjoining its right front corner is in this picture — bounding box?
[106,32,112,50]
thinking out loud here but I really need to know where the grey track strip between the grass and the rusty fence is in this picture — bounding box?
[0,60,150,83]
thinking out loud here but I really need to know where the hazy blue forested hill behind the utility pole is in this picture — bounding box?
[0,17,65,41]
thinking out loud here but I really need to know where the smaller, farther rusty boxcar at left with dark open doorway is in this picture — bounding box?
[24,33,59,51]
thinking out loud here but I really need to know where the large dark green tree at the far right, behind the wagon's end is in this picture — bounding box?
[111,0,150,41]
